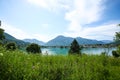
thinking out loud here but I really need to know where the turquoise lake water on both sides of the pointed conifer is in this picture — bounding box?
[41,47,116,55]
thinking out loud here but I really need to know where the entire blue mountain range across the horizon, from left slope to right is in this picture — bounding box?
[4,33,112,46]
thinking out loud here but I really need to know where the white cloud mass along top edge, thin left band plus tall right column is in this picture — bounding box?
[27,0,105,31]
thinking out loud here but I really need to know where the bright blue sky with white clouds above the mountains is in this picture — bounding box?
[0,0,120,42]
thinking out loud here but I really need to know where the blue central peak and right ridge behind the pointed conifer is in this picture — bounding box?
[45,36,105,46]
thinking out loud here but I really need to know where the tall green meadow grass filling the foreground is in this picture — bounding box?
[0,47,120,80]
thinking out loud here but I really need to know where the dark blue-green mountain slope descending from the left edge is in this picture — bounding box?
[4,33,29,46]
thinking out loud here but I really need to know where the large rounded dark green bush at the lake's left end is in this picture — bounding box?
[26,43,41,53]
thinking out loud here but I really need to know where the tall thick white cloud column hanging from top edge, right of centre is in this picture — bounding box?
[65,0,105,31]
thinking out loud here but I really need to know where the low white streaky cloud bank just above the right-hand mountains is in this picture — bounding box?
[64,23,120,40]
